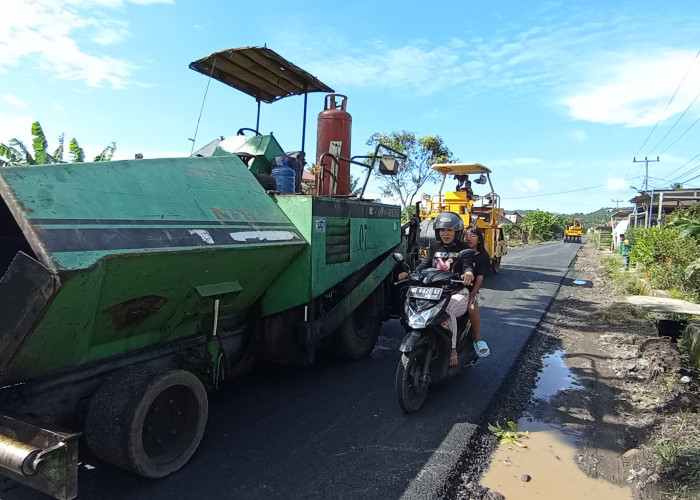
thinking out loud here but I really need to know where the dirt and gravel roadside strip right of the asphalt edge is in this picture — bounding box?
[439,243,700,500]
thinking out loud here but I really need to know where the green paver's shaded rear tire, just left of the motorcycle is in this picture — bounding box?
[332,285,384,361]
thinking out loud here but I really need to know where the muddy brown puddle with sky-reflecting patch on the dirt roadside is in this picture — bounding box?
[480,351,632,500]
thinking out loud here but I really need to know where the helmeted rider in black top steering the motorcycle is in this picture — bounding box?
[398,212,476,366]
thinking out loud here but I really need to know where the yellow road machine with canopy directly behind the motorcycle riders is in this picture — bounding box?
[418,163,508,273]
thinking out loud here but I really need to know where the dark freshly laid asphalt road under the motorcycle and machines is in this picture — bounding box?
[0,242,581,500]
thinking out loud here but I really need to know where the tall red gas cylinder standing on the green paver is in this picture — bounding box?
[316,94,352,196]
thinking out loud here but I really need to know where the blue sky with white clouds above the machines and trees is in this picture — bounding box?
[0,0,700,213]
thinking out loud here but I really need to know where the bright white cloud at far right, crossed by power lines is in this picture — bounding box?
[565,51,700,127]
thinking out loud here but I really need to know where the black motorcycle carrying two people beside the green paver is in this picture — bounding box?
[394,250,479,413]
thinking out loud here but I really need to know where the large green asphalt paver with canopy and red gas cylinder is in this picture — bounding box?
[0,47,404,499]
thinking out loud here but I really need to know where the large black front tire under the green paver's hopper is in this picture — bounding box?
[84,367,209,478]
